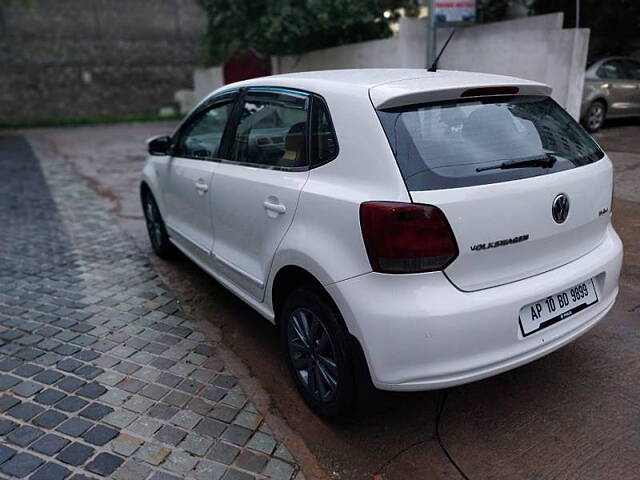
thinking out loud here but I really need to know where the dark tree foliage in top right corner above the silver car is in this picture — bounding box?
[533,0,640,56]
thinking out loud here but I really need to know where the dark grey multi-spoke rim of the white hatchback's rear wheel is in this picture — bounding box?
[288,309,339,401]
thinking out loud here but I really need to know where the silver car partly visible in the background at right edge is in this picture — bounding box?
[580,57,640,132]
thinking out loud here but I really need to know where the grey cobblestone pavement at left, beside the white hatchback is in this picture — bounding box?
[0,136,302,480]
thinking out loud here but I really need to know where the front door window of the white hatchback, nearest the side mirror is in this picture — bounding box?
[173,102,233,159]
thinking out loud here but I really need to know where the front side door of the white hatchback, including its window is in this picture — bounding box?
[164,93,237,263]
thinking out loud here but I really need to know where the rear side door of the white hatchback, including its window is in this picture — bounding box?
[211,88,309,300]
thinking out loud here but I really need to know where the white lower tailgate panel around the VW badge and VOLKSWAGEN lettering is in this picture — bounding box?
[411,156,613,291]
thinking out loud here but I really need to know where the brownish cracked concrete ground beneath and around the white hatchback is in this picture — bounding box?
[10,117,640,479]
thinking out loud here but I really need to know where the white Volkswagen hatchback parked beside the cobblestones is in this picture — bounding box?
[141,69,622,416]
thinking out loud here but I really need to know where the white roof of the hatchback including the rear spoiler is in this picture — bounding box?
[217,68,551,108]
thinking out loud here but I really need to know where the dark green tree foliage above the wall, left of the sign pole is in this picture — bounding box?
[199,0,391,64]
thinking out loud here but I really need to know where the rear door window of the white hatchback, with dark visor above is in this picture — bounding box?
[230,92,308,168]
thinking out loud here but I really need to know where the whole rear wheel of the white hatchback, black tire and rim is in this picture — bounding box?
[278,285,357,419]
